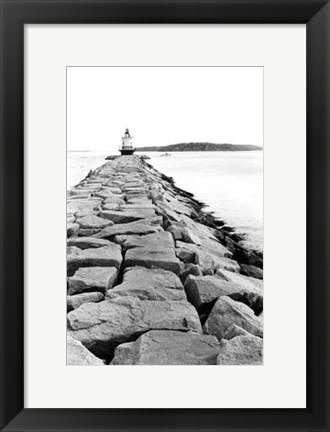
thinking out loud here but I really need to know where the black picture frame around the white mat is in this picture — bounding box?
[0,0,330,432]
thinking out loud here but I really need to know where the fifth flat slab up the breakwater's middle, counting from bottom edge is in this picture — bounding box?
[115,231,174,251]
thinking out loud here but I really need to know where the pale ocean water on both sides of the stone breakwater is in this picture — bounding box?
[67,151,263,251]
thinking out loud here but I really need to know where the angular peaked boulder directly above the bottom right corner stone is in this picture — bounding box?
[204,296,263,340]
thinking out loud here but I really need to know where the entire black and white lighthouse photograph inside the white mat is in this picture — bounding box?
[66,66,264,367]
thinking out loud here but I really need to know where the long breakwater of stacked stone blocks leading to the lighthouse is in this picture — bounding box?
[67,156,263,366]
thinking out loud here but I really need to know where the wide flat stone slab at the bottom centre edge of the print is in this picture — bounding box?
[110,330,220,365]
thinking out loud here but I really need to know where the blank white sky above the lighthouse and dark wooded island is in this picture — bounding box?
[67,67,263,154]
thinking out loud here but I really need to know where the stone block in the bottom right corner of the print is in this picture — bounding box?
[217,336,263,365]
